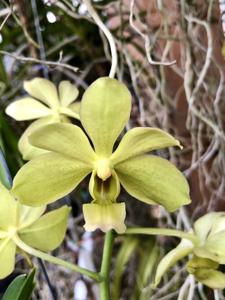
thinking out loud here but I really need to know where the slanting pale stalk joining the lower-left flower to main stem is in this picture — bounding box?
[12,235,101,282]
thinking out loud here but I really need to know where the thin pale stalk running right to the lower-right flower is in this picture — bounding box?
[125,227,198,244]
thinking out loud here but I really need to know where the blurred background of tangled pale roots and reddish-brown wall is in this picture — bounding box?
[0,0,225,300]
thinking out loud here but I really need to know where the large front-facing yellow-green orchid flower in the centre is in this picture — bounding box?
[13,77,190,233]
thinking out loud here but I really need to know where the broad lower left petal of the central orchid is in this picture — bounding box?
[12,153,91,206]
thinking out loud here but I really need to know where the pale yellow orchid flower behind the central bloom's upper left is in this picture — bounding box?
[6,78,79,160]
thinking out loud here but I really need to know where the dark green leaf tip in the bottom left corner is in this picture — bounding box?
[2,269,35,300]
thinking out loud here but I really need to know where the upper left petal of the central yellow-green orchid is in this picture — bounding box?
[29,124,96,167]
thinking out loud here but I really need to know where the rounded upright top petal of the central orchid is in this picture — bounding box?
[80,77,131,158]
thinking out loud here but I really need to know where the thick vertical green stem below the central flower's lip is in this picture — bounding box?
[100,230,115,300]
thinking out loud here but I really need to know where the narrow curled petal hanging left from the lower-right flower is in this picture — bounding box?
[153,239,193,287]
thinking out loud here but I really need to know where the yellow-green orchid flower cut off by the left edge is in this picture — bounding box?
[0,183,70,279]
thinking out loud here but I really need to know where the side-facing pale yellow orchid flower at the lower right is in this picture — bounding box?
[154,212,225,289]
